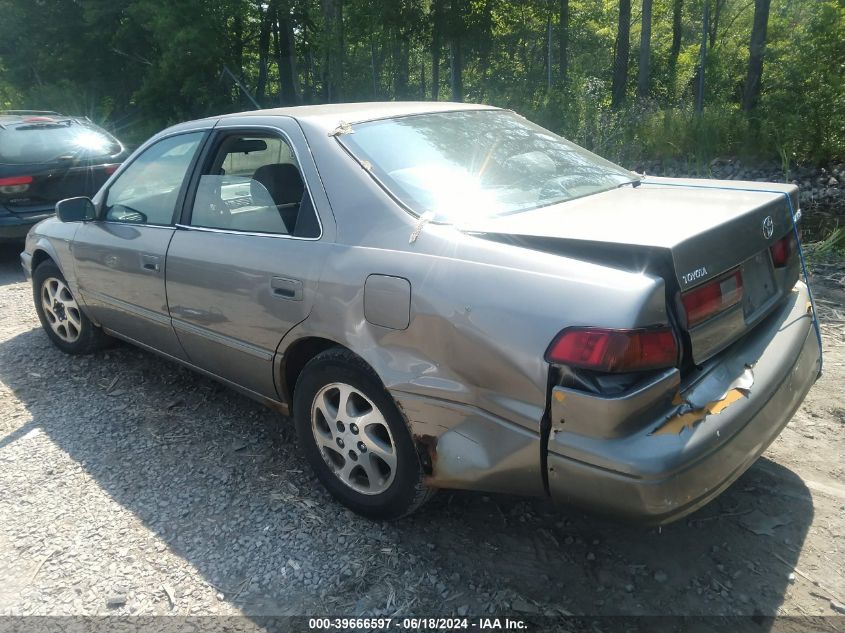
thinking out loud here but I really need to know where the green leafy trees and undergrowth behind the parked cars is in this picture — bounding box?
[0,0,845,163]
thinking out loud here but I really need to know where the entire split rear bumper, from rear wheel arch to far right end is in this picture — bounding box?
[392,283,820,523]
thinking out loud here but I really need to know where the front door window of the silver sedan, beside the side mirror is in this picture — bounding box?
[105,132,204,225]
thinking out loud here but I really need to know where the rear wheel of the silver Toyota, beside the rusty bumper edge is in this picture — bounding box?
[293,347,434,519]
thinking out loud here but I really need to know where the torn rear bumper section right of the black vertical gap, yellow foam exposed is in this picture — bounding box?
[548,283,820,523]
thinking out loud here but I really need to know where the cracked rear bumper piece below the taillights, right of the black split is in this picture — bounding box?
[548,284,821,524]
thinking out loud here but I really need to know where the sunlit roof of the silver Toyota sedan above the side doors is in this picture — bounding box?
[217,101,498,130]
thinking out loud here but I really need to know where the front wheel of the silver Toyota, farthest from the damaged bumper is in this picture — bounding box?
[32,259,114,354]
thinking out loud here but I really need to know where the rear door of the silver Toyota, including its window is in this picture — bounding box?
[167,117,327,398]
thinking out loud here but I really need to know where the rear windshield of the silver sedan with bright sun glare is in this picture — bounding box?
[338,110,638,224]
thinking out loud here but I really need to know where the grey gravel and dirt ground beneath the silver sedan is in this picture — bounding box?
[0,243,845,624]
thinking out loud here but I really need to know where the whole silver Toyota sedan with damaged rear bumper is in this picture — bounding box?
[21,103,821,523]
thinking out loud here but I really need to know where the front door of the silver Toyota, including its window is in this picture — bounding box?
[73,131,206,359]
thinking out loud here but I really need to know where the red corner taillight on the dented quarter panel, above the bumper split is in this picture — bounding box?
[546,327,678,372]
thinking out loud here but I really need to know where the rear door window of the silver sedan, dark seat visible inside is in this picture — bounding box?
[191,134,320,237]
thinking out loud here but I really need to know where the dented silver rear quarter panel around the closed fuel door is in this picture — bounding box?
[292,114,667,414]
